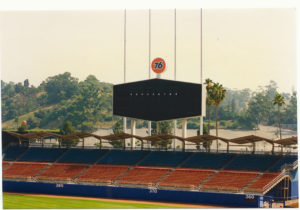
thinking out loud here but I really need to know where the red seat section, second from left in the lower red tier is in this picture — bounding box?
[38,163,88,180]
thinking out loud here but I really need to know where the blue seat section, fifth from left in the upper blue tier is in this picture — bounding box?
[139,152,190,167]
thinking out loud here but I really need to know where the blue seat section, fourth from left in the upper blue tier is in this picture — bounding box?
[97,150,148,165]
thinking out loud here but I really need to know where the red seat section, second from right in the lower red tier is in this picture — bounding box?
[200,170,258,191]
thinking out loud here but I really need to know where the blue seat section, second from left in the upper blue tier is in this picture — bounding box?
[19,147,66,162]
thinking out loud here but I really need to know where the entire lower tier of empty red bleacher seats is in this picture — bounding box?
[3,162,288,192]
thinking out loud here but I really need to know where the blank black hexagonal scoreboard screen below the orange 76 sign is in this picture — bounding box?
[113,79,202,121]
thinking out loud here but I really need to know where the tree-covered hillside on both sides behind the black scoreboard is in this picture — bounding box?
[1,72,297,133]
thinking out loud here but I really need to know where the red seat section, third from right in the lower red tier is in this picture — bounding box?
[159,169,214,188]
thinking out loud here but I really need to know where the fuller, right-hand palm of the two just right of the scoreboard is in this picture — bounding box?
[211,83,226,151]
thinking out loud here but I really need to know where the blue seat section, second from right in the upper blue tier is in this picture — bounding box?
[225,155,280,171]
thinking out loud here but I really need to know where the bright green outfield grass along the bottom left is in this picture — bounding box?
[3,194,187,209]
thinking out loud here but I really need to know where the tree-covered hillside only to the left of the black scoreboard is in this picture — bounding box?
[1,72,112,131]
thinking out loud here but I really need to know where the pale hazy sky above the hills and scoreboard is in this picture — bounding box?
[0,9,296,92]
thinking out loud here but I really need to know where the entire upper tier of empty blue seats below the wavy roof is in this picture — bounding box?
[3,146,297,172]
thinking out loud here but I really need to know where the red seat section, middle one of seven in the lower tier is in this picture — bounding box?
[117,166,170,185]
